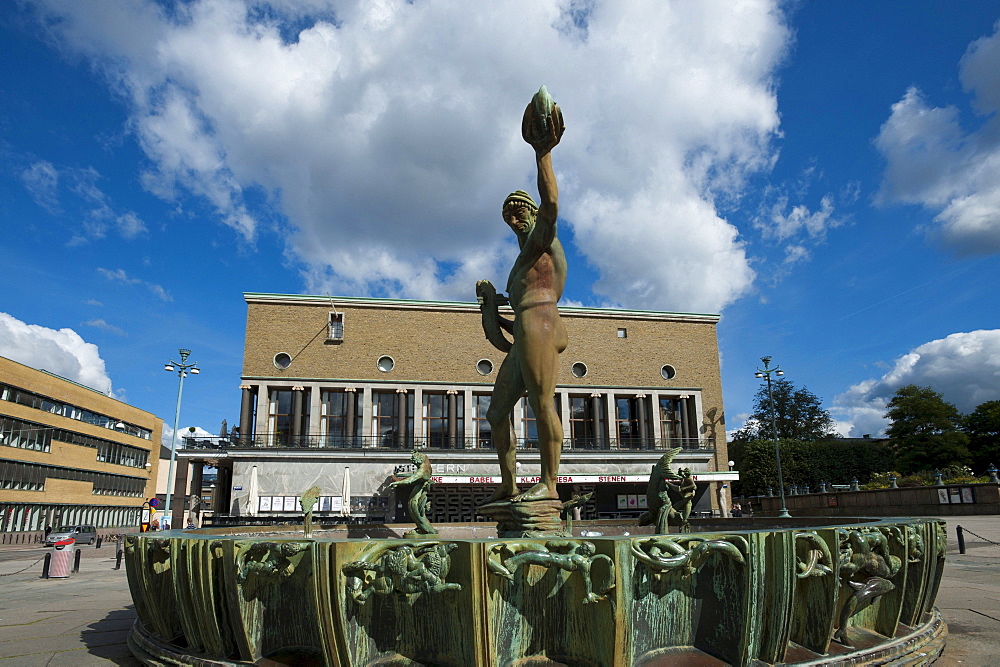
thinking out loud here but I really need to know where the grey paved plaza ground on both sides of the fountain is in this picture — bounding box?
[0,516,1000,667]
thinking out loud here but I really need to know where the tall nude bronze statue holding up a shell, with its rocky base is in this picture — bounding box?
[476,86,567,524]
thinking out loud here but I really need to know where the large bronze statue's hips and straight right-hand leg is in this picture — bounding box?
[510,304,566,500]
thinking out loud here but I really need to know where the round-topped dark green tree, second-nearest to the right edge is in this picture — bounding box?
[885,384,972,474]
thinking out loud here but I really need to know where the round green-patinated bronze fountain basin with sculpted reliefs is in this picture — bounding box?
[125,517,946,666]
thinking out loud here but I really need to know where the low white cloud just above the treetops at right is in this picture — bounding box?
[831,329,1000,437]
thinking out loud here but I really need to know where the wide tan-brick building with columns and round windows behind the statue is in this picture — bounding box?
[175,294,736,522]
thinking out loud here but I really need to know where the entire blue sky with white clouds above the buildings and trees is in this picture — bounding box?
[0,0,1000,448]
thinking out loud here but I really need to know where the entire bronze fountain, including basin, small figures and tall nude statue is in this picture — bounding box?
[125,87,947,667]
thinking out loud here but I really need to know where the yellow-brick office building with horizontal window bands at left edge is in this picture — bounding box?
[0,357,163,532]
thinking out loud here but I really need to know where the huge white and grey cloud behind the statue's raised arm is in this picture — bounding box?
[25,0,789,312]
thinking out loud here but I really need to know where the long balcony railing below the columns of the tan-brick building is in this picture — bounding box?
[181,433,715,452]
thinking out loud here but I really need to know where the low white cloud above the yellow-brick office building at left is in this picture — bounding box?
[0,313,111,395]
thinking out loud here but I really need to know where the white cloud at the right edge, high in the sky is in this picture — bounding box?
[875,23,1000,253]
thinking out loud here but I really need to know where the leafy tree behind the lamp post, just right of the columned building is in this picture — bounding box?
[732,378,833,446]
